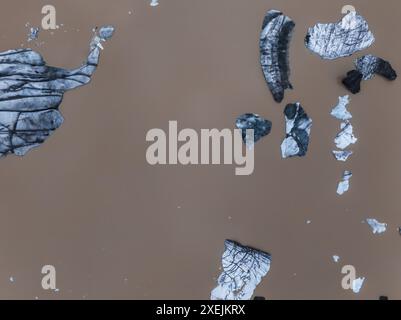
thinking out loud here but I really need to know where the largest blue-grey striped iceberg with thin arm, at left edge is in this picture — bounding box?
[0,27,114,156]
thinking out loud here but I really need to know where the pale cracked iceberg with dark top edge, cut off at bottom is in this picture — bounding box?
[211,240,271,300]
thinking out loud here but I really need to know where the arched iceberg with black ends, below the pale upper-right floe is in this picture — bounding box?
[343,55,397,94]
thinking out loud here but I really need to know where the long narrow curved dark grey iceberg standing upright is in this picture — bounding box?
[259,10,295,102]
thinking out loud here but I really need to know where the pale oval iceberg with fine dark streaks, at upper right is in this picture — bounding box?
[305,11,375,60]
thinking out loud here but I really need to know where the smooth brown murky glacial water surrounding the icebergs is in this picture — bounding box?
[0,0,401,299]
